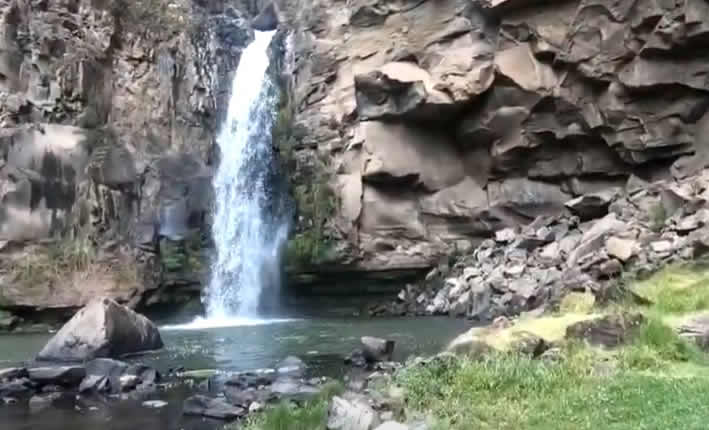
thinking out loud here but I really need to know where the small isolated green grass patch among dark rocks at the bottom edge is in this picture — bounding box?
[238,382,343,430]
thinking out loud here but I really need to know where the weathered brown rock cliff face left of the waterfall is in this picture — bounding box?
[0,0,258,316]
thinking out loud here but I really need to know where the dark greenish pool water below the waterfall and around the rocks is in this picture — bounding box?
[0,318,470,430]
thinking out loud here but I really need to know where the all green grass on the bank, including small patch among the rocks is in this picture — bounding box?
[234,267,709,430]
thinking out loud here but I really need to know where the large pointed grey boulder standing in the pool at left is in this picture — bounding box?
[37,298,163,361]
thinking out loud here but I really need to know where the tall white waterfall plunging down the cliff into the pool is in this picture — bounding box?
[204,31,288,321]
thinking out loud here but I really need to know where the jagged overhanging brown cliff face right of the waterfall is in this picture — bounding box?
[278,0,709,290]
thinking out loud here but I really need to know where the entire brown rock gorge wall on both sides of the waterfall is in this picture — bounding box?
[0,0,709,312]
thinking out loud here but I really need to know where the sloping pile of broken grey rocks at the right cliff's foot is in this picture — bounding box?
[372,170,709,320]
